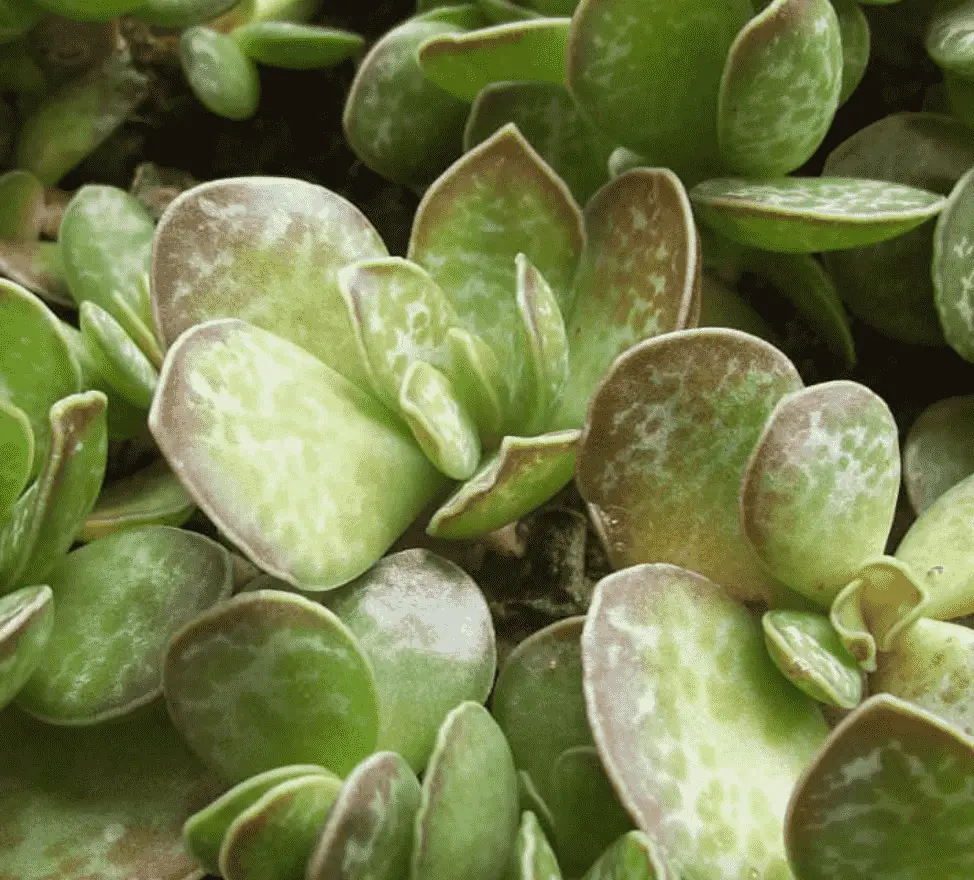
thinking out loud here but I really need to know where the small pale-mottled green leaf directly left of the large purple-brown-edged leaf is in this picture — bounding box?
[60,186,162,360]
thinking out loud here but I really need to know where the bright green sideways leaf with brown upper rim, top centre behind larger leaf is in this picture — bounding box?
[418,18,571,101]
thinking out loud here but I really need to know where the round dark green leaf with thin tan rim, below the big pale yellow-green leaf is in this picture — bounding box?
[163,590,379,781]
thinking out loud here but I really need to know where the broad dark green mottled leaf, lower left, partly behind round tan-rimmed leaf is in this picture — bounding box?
[17,526,231,724]
